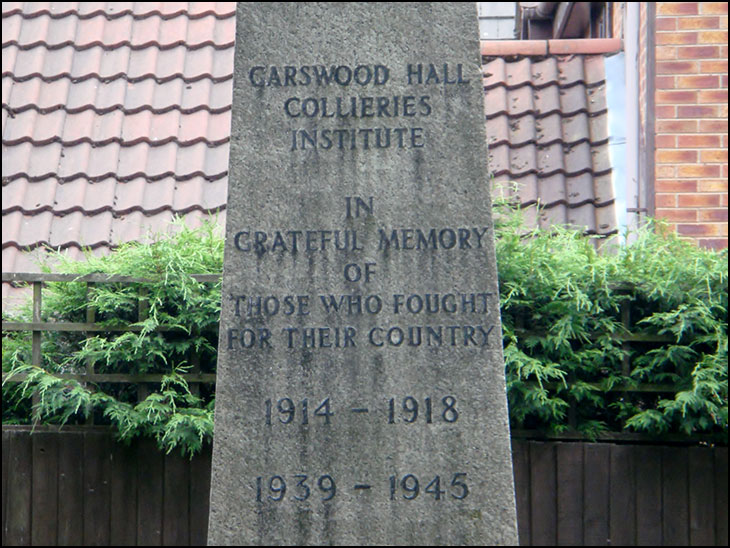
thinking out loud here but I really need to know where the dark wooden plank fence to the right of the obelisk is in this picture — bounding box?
[512,439,728,546]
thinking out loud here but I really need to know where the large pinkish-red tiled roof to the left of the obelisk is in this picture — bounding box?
[2,2,235,306]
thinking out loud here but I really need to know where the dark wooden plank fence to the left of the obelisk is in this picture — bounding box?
[2,426,210,546]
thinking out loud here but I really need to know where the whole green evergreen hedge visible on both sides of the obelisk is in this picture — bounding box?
[3,210,728,456]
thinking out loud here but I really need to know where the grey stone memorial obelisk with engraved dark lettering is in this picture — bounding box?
[208,3,517,545]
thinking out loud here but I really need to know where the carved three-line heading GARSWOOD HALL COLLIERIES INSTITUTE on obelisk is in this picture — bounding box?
[248,63,469,152]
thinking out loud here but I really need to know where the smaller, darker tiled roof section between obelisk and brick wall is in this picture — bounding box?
[482,47,616,235]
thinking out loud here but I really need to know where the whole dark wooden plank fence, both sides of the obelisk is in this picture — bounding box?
[2,426,728,546]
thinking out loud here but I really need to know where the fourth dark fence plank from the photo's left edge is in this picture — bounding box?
[84,432,111,546]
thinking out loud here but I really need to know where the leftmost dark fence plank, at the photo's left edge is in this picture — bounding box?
[3,433,33,546]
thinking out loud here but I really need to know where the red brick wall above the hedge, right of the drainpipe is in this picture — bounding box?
[655,2,728,248]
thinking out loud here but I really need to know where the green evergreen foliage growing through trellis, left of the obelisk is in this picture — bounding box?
[3,221,223,456]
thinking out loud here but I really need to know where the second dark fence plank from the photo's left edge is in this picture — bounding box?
[31,432,58,546]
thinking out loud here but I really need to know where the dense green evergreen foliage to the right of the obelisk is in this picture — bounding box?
[496,206,728,443]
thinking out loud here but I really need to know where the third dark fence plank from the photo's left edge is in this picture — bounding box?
[57,432,84,546]
